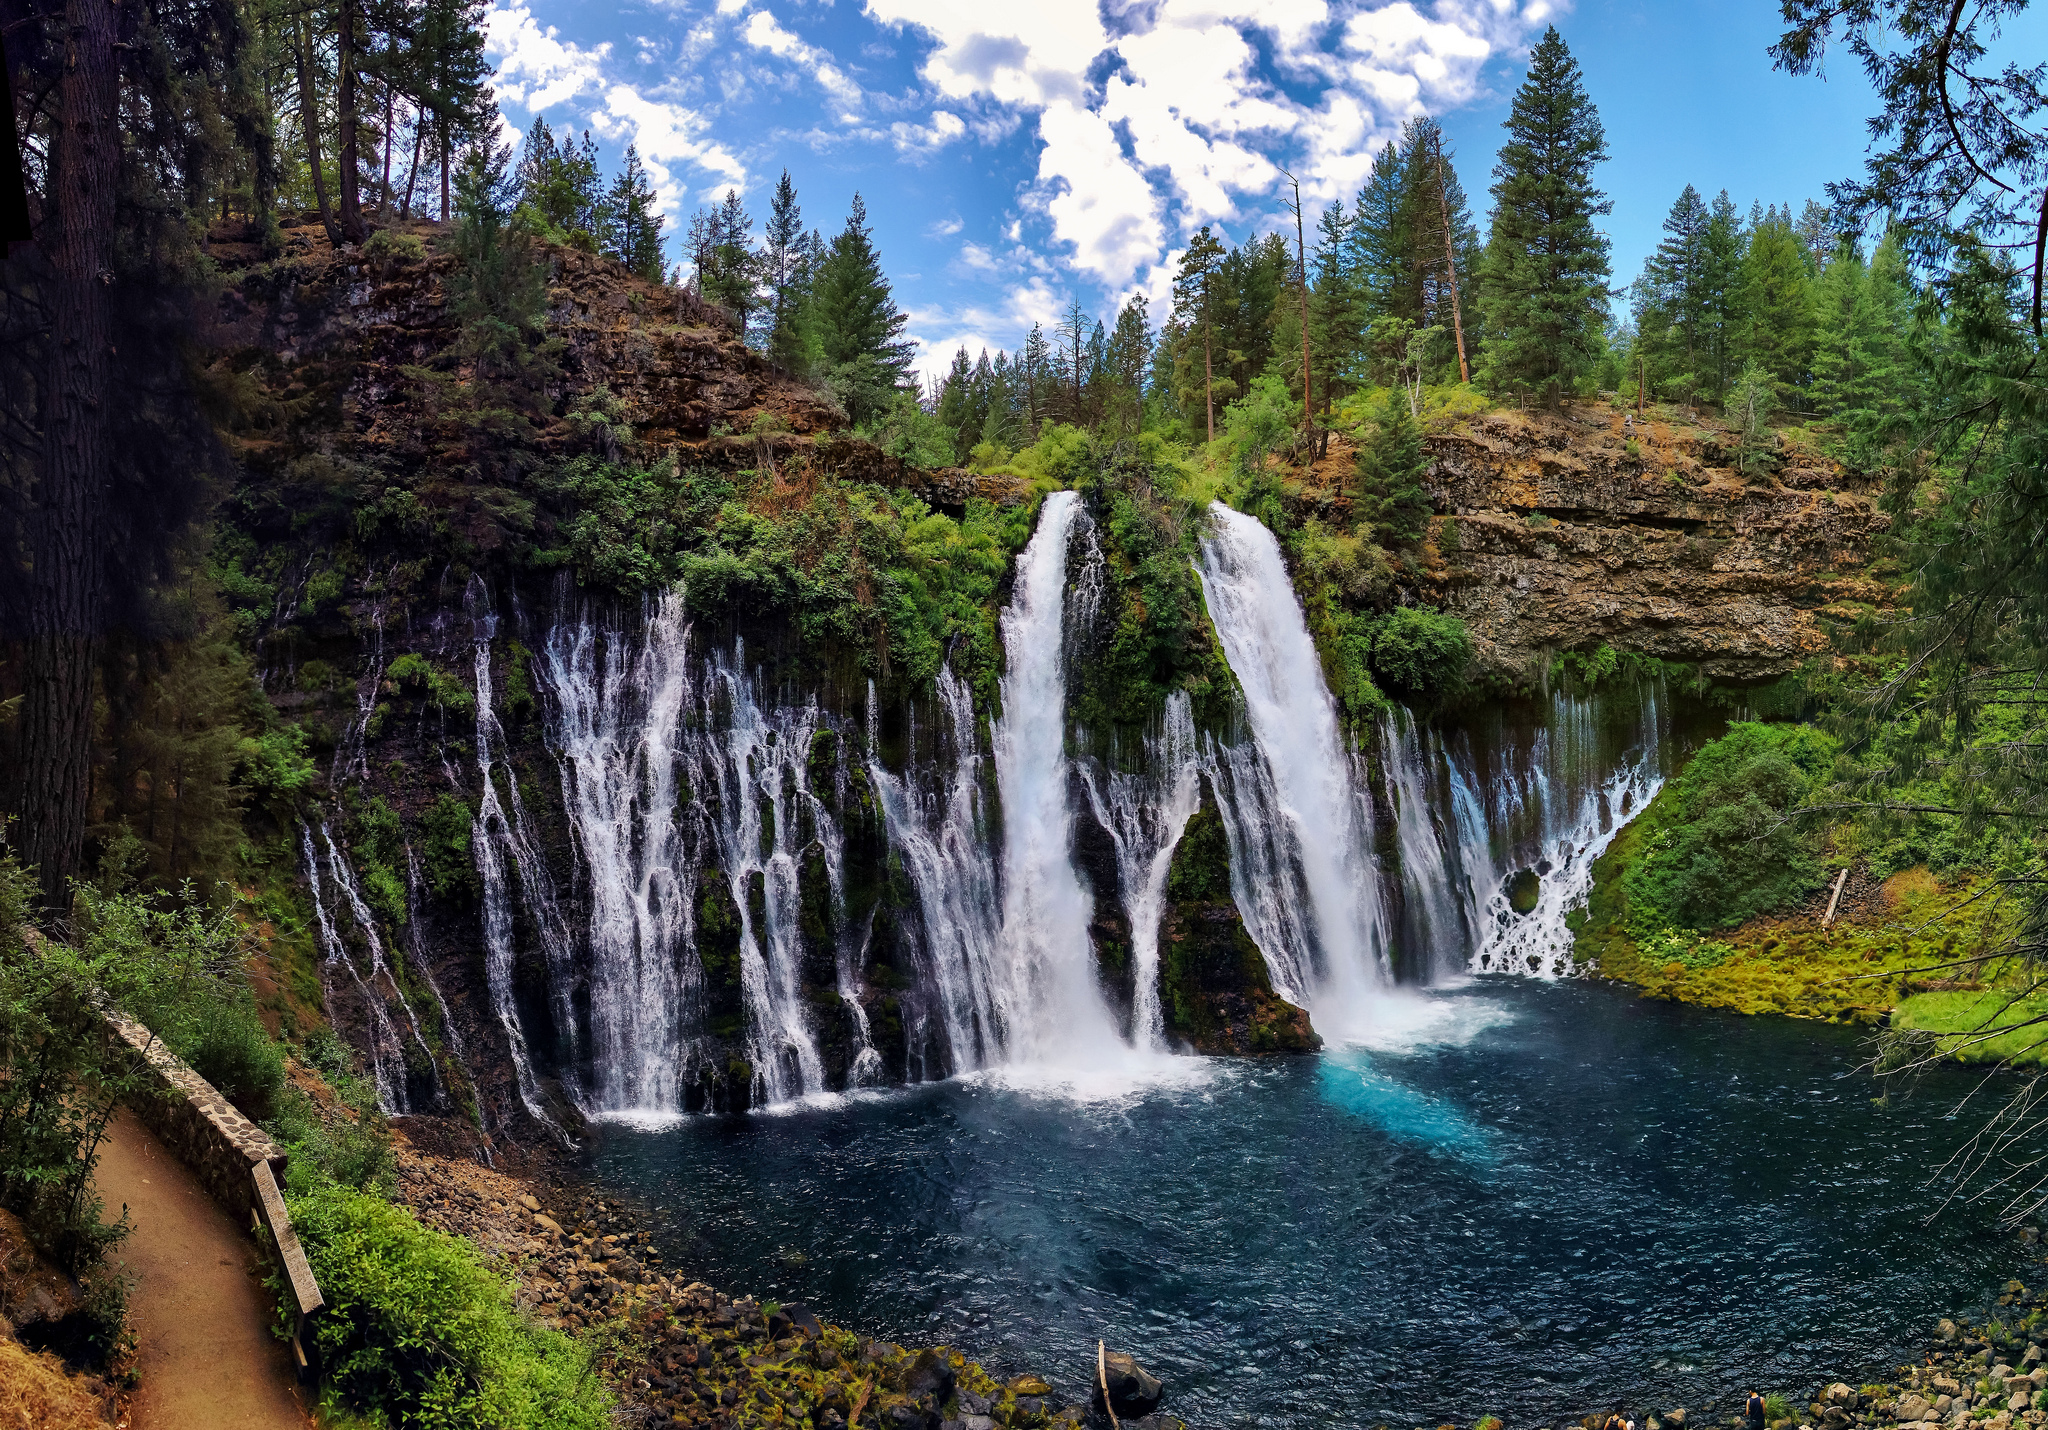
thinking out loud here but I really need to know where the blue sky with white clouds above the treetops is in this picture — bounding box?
[487,0,1925,387]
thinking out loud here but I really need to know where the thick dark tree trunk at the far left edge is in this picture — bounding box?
[20,0,121,914]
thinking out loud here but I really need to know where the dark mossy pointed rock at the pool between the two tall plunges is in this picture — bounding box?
[1159,781,1323,1055]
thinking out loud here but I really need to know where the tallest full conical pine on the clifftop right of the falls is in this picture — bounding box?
[1481,25,1614,406]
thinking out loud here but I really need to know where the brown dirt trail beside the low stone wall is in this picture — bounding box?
[92,1108,311,1430]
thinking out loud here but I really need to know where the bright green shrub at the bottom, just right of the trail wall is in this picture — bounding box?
[281,1184,610,1430]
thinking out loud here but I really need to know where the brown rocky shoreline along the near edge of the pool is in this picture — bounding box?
[395,1135,2048,1430]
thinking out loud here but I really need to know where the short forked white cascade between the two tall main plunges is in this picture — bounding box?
[1083,690,1202,1051]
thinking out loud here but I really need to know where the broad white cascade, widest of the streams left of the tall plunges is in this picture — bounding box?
[539,592,700,1117]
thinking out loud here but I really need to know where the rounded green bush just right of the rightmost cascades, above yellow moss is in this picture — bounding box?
[1624,723,1835,938]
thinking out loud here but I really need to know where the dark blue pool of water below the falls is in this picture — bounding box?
[592,977,2023,1430]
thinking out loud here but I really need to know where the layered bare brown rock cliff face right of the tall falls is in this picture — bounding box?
[1427,406,1890,682]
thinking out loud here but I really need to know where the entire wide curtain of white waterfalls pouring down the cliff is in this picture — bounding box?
[407,492,1669,1125]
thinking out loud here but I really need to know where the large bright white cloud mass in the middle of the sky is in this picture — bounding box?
[868,0,1559,280]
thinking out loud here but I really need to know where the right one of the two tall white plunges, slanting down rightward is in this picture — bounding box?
[1196,502,1389,1037]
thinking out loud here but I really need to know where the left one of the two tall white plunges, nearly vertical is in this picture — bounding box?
[991,492,1122,1067]
